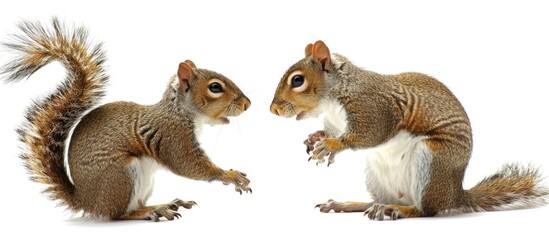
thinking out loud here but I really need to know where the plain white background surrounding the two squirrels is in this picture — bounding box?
[0,0,549,239]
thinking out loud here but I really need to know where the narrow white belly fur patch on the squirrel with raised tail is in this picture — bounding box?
[126,157,161,212]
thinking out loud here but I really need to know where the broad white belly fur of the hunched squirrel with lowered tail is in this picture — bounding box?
[365,131,432,209]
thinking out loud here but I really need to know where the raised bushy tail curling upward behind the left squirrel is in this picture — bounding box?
[0,18,108,209]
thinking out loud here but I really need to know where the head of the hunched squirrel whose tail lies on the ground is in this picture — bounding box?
[271,40,335,120]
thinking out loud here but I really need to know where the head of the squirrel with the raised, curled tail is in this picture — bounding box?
[172,60,251,124]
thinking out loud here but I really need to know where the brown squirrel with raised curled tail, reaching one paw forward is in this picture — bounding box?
[2,18,252,221]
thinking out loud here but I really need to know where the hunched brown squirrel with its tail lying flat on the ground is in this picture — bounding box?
[270,41,549,220]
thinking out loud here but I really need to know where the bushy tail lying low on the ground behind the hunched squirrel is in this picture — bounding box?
[466,164,549,211]
